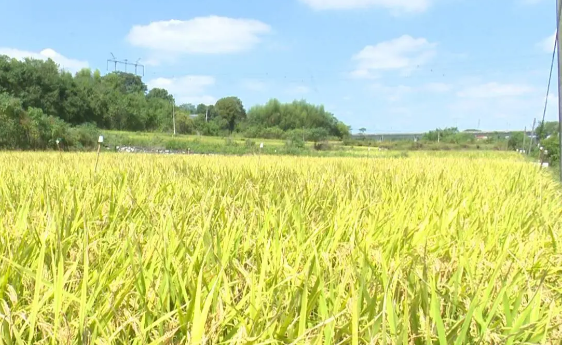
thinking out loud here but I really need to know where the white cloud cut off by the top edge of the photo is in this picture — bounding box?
[301,0,426,12]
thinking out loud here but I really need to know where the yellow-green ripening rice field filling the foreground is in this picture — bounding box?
[0,153,562,345]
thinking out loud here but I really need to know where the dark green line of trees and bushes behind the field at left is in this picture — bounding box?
[0,56,349,149]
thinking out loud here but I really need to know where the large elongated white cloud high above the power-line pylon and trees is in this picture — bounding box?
[127,16,271,54]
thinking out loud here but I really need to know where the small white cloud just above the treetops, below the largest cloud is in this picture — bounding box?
[146,75,216,104]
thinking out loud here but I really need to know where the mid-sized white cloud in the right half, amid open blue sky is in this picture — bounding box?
[352,35,436,78]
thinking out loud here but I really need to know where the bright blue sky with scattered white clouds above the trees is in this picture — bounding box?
[0,0,557,133]
